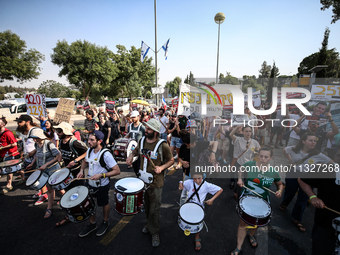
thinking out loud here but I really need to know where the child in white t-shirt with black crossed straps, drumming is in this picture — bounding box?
[178,173,223,251]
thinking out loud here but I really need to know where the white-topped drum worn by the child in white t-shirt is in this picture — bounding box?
[178,202,204,234]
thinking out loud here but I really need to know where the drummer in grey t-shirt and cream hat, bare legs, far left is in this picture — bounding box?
[26,128,60,219]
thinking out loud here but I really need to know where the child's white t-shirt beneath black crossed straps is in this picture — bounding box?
[183,179,221,208]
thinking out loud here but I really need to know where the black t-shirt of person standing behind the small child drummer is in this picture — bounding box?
[178,142,210,175]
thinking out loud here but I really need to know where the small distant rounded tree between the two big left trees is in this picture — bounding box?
[37,80,72,98]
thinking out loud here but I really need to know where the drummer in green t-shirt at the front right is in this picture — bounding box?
[231,147,283,255]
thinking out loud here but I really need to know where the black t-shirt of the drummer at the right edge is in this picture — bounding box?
[301,178,340,227]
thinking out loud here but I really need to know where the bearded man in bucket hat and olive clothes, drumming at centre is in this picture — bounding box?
[126,119,174,247]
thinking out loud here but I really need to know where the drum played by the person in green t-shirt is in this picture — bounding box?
[236,195,272,227]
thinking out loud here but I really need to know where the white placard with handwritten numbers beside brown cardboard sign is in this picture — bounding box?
[24,94,47,117]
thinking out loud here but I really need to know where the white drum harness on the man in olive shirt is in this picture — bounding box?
[137,136,165,189]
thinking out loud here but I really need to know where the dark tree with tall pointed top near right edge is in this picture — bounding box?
[298,28,340,78]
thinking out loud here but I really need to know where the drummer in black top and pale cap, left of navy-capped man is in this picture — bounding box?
[54,122,87,227]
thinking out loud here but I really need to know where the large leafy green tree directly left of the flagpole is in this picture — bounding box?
[108,45,155,99]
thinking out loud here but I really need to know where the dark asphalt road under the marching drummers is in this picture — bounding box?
[0,160,314,255]
